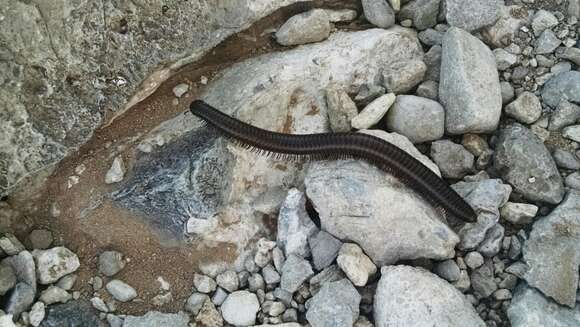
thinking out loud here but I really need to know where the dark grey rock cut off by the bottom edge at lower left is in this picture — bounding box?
[40,300,101,327]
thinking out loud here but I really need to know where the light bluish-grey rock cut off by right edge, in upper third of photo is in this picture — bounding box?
[542,71,580,108]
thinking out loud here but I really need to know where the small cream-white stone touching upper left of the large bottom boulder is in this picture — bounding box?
[336,243,377,286]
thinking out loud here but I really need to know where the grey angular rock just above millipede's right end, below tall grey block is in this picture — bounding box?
[431,140,474,179]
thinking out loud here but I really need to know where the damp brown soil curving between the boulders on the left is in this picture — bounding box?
[8,0,368,315]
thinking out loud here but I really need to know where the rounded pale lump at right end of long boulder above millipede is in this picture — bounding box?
[383,60,427,94]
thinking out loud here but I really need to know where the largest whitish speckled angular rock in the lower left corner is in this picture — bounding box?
[33,246,80,285]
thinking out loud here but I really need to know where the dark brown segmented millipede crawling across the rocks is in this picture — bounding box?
[190,100,477,221]
